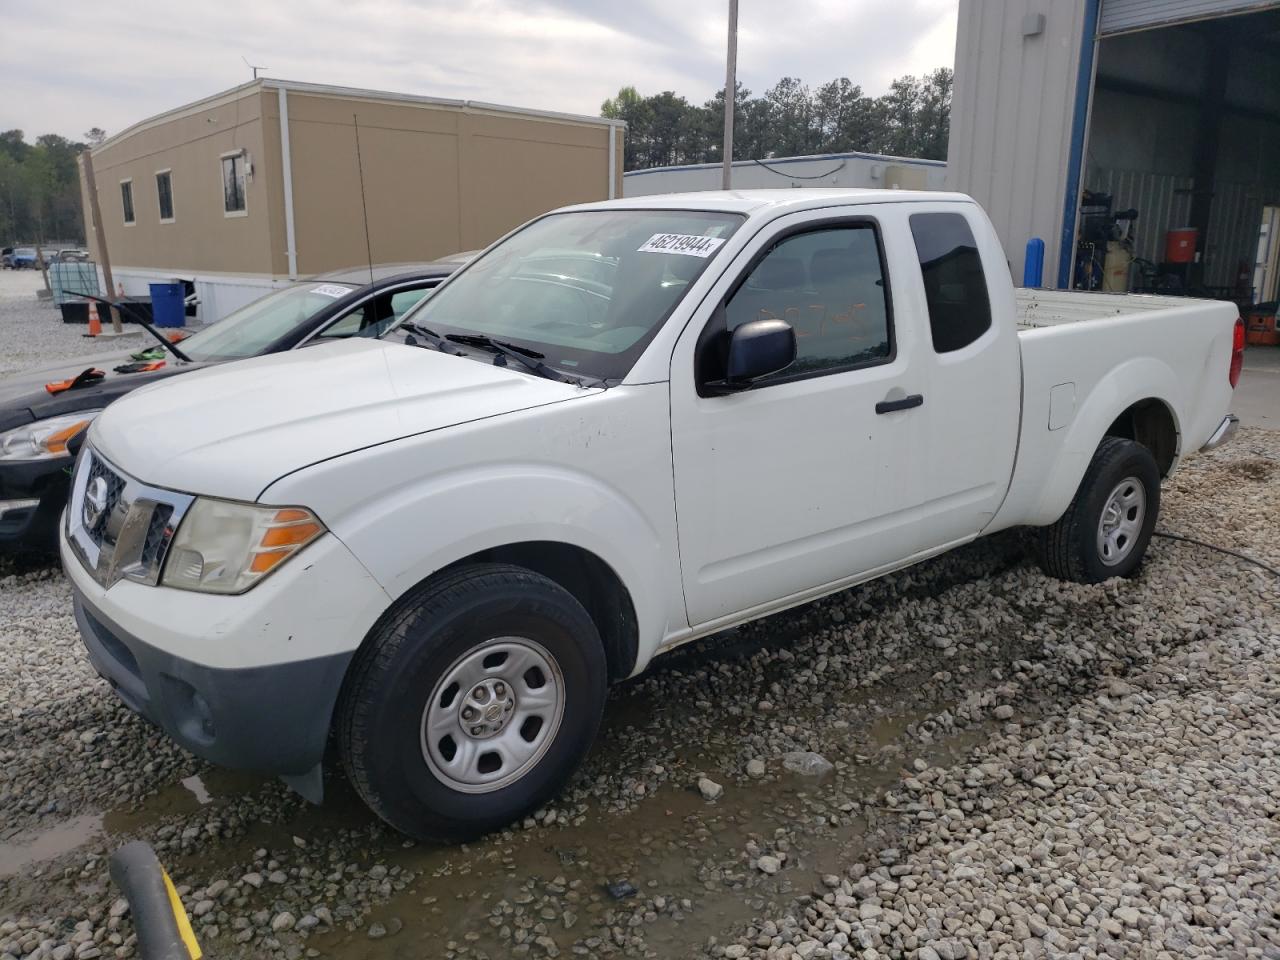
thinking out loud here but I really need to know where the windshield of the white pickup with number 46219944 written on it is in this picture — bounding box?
[396,210,742,380]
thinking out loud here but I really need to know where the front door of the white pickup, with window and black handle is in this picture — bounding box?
[671,206,932,625]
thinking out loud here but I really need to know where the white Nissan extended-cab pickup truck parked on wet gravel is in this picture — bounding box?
[61,189,1243,838]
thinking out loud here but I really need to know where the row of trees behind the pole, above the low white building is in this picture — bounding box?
[600,67,952,170]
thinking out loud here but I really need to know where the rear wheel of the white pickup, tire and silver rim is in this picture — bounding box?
[1039,436,1160,584]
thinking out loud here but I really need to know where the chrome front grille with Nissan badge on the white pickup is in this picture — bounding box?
[65,444,195,586]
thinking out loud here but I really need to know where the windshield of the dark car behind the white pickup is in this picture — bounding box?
[182,283,356,360]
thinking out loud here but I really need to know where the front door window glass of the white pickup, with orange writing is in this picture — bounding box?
[724,221,893,384]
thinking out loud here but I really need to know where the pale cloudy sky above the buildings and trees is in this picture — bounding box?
[0,0,957,141]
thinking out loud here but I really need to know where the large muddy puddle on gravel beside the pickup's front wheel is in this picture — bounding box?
[294,707,989,960]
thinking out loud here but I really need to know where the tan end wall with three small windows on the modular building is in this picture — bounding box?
[87,91,279,274]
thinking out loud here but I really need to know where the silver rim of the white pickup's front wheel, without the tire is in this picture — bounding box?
[421,636,564,794]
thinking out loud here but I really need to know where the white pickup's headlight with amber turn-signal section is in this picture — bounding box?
[160,497,324,594]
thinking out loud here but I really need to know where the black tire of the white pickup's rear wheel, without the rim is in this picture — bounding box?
[1039,436,1160,584]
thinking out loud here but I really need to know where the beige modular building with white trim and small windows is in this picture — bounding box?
[81,78,625,323]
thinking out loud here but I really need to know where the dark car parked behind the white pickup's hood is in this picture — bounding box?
[0,257,465,553]
